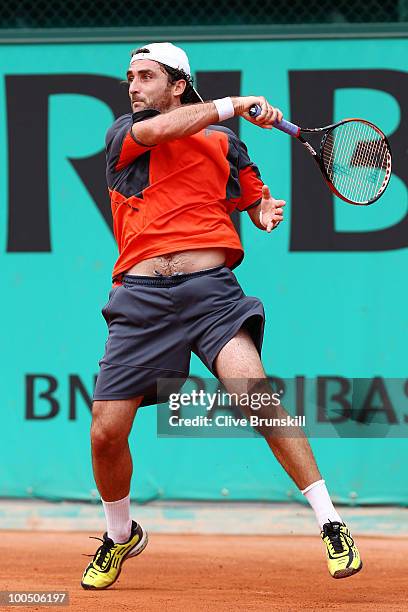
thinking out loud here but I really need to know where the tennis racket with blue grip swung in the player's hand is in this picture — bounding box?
[249,104,392,206]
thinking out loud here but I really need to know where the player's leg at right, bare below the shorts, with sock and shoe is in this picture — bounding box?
[214,328,362,578]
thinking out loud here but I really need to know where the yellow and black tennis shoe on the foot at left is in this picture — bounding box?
[81,521,147,589]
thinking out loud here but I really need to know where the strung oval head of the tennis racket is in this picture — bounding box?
[321,121,391,204]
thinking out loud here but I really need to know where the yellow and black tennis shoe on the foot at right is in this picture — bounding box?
[321,521,363,578]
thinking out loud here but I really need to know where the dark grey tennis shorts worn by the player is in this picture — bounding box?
[94,266,265,406]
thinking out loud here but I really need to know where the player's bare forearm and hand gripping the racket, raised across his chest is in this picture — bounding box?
[132,96,282,146]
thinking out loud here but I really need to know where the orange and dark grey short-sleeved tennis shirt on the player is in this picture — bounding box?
[106,110,263,281]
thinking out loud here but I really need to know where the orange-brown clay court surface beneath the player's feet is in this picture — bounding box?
[0,531,408,612]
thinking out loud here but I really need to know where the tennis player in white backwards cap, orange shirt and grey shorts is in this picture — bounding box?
[81,43,362,589]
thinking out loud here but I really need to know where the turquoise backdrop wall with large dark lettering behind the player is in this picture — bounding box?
[0,39,408,504]
